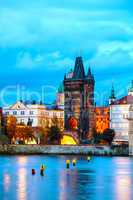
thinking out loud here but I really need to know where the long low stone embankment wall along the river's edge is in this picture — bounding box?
[0,145,129,156]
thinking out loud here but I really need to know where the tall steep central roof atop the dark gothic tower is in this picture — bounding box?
[73,57,85,79]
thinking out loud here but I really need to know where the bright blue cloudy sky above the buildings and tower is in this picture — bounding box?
[0,0,133,106]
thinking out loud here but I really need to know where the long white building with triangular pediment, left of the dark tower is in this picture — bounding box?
[3,101,64,130]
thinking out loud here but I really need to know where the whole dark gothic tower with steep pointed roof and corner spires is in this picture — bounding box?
[64,57,95,139]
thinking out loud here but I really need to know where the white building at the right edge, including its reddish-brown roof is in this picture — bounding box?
[110,82,133,142]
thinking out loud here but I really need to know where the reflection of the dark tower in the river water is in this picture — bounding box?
[59,169,94,200]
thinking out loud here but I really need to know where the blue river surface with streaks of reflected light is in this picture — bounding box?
[0,156,133,200]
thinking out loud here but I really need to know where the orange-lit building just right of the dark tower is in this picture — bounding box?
[95,107,110,133]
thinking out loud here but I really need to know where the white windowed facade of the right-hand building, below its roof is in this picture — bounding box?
[110,104,130,141]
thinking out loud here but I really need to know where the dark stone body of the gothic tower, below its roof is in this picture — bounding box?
[64,79,94,138]
